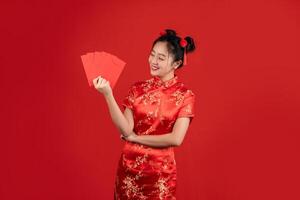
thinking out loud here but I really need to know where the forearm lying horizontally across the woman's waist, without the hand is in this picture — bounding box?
[134,133,178,147]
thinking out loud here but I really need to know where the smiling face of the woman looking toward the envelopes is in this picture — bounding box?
[149,42,180,77]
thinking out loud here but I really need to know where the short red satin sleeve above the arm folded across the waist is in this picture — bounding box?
[177,90,195,123]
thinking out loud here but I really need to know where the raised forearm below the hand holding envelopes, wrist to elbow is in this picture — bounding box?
[104,93,130,136]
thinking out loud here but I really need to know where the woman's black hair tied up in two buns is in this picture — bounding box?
[152,29,196,69]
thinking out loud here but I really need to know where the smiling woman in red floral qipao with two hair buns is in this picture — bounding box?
[94,29,195,200]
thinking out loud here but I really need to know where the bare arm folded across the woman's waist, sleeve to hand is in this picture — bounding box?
[127,117,190,147]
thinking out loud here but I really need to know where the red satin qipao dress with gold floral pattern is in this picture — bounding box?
[114,75,195,200]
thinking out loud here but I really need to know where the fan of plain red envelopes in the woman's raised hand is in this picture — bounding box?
[81,51,126,88]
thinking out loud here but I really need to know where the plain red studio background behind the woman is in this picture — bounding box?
[0,0,300,200]
